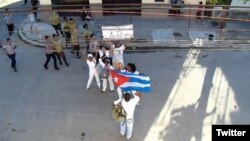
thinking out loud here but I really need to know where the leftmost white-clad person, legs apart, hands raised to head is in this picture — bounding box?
[86,54,101,90]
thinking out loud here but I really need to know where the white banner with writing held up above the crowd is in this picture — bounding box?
[102,25,134,40]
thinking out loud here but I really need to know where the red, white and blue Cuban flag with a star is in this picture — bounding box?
[110,70,151,92]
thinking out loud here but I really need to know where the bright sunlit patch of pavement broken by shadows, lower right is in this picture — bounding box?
[144,50,239,141]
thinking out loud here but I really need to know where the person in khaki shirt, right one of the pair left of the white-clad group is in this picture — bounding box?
[52,34,69,66]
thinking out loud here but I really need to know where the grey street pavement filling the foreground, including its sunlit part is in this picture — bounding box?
[0,45,250,141]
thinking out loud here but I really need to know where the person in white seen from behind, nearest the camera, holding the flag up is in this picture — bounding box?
[120,91,141,140]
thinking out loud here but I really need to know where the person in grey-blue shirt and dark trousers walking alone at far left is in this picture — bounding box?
[3,38,17,72]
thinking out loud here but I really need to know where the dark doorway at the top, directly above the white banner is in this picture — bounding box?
[102,0,141,15]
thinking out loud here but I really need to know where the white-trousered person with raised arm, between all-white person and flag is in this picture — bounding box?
[99,56,115,93]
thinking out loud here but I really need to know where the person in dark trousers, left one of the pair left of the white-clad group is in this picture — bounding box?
[43,35,59,70]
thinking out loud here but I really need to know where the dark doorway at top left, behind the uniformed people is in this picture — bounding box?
[51,0,89,16]
